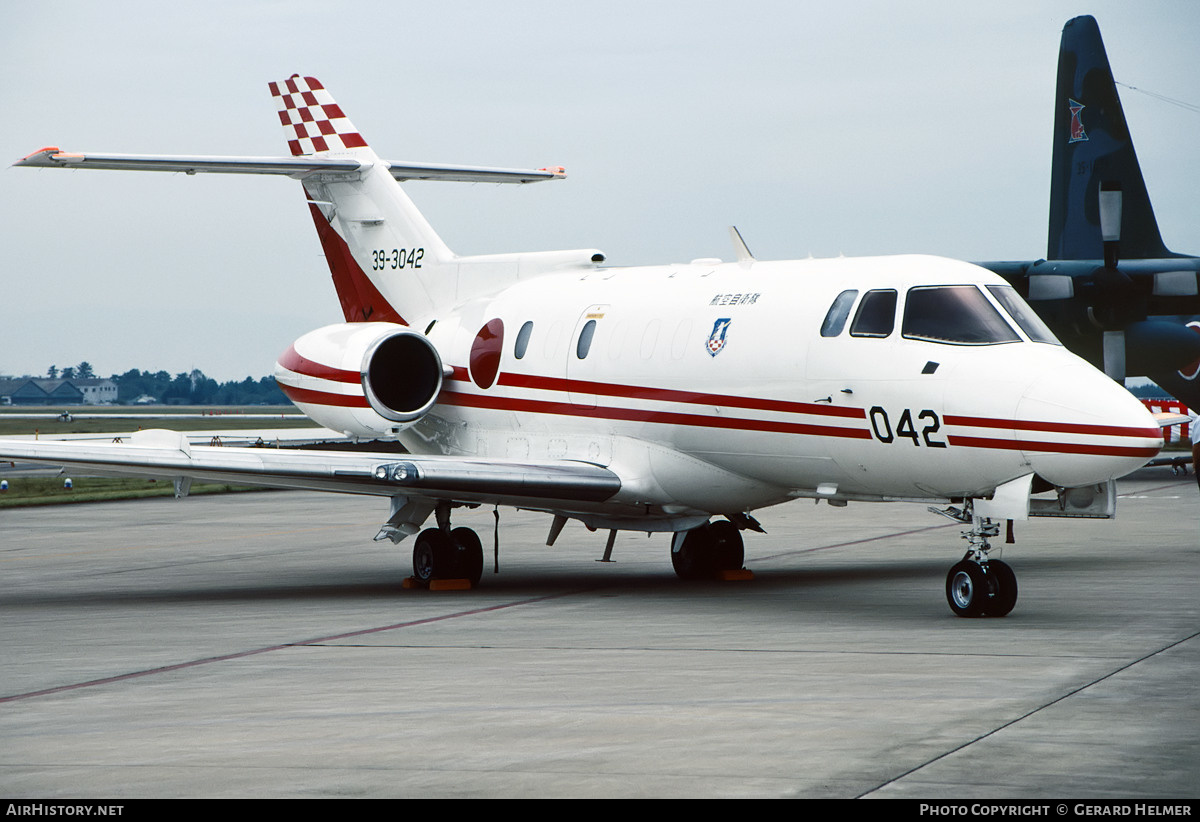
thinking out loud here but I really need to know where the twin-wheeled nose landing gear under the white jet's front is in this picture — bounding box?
[936,508,1016,617]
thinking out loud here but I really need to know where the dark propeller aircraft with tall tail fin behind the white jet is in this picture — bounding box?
[980,17,1200,408]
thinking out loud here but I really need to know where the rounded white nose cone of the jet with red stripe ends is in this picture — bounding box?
[1016,360,1163,487]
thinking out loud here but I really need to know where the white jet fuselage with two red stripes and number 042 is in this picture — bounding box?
[306,256,1162,512]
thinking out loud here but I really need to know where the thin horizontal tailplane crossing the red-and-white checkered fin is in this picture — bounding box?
[13,146,566,182]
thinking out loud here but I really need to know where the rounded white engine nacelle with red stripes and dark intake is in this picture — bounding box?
[275,323,443,439]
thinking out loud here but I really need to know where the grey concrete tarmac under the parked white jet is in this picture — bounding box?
[0,469,1200,799]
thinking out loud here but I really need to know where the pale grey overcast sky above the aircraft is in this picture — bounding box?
[0,0,1200,380]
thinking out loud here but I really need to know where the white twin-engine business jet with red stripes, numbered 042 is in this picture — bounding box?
[0,76,1163,617]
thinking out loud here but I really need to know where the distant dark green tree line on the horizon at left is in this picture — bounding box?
[46,362,292,406]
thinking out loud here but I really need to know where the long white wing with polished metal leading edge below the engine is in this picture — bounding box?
[0,430,620,505]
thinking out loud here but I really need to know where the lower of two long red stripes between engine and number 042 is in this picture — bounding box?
[438,391,871,439]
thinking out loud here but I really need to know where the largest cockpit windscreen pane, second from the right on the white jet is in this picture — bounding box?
[902,286,1021,346]
